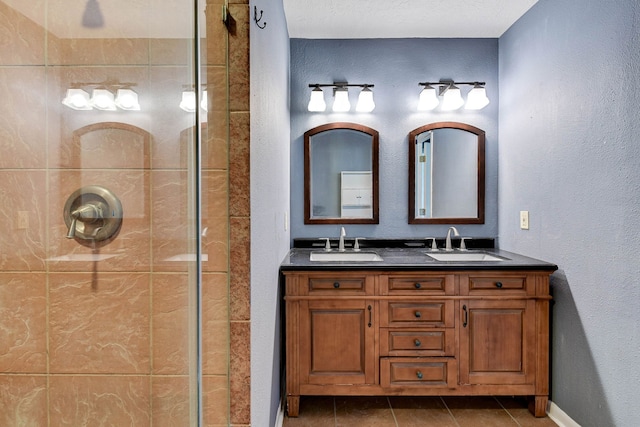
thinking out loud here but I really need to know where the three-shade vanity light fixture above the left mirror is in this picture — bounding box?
[307,82,376,113]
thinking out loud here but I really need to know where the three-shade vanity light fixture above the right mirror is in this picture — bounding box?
[418,80,489,111]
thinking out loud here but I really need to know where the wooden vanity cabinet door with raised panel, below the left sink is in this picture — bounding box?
[300,300,376,384]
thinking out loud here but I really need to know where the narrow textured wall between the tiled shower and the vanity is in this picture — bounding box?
[251,0,289,427]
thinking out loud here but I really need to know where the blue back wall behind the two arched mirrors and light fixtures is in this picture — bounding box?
[290,39,498,241]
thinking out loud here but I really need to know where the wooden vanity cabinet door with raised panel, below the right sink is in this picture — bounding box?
[460,300,536,385]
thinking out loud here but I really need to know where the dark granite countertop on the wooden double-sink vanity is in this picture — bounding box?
[280,247,558,271]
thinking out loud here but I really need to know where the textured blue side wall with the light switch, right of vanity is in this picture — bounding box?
[499,0,640,427]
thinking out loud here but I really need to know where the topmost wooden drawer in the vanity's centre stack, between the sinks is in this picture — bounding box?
[381,274,454,296]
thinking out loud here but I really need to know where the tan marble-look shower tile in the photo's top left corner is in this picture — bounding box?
[0,0,46,65]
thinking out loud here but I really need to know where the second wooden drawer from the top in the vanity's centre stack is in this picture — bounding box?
[380,300,454,328]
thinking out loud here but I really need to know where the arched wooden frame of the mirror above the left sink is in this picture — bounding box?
[304,122,379,224]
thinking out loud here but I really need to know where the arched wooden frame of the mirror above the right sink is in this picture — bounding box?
[409,122,485,224]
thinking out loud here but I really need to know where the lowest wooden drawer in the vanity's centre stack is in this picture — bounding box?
[380,357,458,388]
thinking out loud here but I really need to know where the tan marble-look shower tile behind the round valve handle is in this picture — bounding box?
[48,169,151,272]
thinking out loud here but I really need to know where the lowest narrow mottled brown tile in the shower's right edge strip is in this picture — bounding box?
[229,321,251,424]
